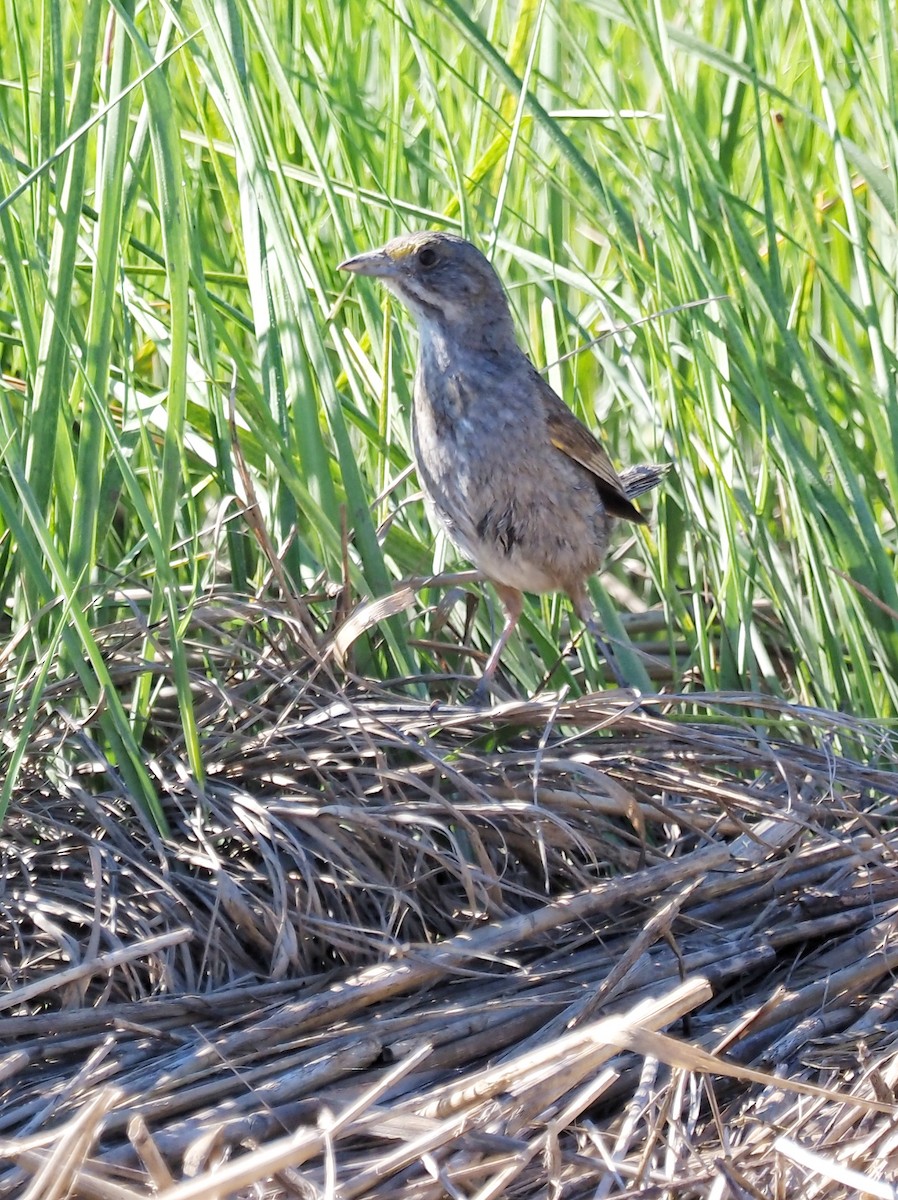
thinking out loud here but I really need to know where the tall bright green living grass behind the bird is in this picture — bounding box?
[0,0,898,803]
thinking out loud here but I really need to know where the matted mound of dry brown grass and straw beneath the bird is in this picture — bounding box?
[0,607,898,1200]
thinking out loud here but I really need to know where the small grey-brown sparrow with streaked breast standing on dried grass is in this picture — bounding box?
[340,230,667,706]
